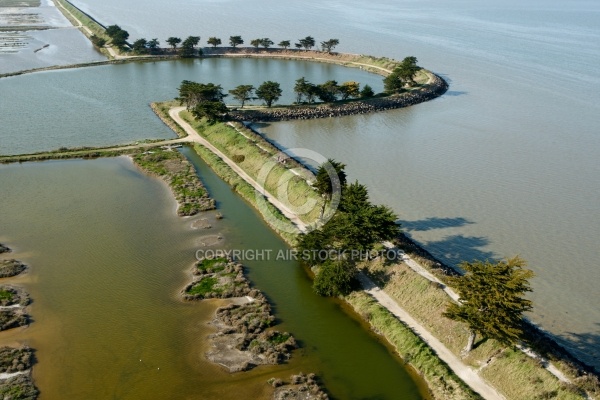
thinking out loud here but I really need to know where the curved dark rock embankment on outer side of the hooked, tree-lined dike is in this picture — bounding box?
[229,73,448,122]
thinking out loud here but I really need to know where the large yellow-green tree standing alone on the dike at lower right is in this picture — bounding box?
[444,257,533,354]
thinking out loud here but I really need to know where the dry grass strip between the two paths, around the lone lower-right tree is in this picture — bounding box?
[360,259,586,400]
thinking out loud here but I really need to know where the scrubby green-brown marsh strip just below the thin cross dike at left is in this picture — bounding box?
[133,149,215,216]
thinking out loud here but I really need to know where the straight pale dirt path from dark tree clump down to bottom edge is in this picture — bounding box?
[358,273,504,400]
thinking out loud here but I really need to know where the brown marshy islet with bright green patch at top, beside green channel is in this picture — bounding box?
[182,258,297,372]
